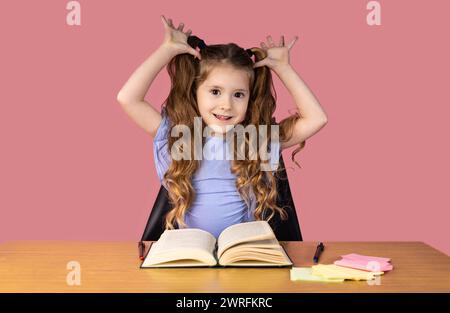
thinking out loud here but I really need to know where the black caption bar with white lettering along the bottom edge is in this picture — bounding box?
[0,293,450,312]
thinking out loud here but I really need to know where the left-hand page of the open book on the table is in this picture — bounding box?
[142,228,216,267]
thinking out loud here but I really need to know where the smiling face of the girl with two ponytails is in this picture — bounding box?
[197,65,250,136]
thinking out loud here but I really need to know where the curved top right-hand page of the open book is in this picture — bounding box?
[217,221,276,259]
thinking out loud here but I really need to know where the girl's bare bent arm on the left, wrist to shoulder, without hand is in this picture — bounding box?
[117,44,176,137]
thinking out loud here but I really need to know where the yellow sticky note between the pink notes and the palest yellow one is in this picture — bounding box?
[312,264,384,280]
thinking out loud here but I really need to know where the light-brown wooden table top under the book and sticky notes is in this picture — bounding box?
[0,241,450,293]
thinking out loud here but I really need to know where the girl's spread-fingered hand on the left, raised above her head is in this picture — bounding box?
[161,15,201,60]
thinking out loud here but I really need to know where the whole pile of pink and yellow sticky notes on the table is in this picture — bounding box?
[291,253,393,282]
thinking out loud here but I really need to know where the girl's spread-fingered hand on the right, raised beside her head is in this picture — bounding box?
[253,35,298,70]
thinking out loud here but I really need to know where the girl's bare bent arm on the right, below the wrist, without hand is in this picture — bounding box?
[273,64,328,149]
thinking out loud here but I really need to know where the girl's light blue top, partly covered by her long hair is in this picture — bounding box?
[153,110,280,238]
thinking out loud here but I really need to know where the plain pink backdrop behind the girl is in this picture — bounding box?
[0,0,450,256]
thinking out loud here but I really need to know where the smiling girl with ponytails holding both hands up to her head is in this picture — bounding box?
[117,16,327,237]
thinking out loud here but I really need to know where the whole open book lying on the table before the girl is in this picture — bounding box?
[141,221,293,268]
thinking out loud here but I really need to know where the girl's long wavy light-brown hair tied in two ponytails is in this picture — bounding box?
[162,36,306,229]
